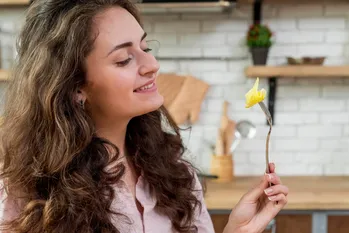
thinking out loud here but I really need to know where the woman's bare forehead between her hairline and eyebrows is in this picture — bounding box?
[93,7,143,45]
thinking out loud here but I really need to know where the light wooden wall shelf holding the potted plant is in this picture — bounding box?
[245,65,349,78]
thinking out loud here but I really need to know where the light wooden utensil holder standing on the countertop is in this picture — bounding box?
[210,154,234,183]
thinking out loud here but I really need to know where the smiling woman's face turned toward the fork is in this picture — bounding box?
[82,7,163,122]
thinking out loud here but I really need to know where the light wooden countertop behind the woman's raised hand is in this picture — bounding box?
[205,176,349,210]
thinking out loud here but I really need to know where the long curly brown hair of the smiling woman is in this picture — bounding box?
[0,0,201,233]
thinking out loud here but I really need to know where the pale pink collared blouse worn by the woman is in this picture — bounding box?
[0,177,214,233]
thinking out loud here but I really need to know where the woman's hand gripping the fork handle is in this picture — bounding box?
[224,163,288,233]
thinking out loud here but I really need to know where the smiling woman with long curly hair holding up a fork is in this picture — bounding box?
[1,0,288,233]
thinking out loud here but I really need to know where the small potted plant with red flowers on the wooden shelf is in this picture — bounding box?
[246,24,273,65]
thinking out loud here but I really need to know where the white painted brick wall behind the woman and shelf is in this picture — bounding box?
[0,3,349,176]
